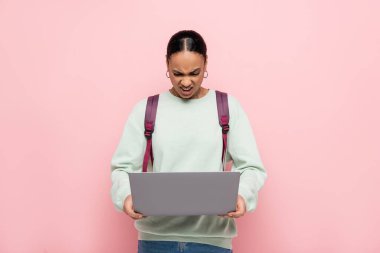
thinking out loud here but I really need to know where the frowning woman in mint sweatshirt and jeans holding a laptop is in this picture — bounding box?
[111,30,267,253]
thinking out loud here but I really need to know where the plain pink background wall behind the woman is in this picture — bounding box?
[0,0,380,253]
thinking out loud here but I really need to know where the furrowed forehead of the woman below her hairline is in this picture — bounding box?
[169,51,204,71]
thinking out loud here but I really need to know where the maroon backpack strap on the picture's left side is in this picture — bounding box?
[142,94,159,172]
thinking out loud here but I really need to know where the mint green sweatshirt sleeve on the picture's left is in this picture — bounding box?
[110,100,146,212]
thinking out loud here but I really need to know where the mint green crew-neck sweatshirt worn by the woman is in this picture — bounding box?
[110,89,267,249]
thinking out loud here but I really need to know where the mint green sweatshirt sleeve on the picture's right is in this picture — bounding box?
[227,96,267,212]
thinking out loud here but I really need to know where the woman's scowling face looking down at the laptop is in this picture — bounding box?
[166,50,207,99]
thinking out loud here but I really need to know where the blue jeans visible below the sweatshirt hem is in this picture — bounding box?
[137,240,232,253]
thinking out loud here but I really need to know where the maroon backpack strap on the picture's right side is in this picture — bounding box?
[215,90,230,170]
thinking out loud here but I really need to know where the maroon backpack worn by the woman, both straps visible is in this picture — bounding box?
[142,90,230,172]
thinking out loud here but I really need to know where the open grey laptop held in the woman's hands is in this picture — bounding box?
[128,171,240,216]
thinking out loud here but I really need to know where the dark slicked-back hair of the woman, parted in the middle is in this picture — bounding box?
[166,30,207,62]
